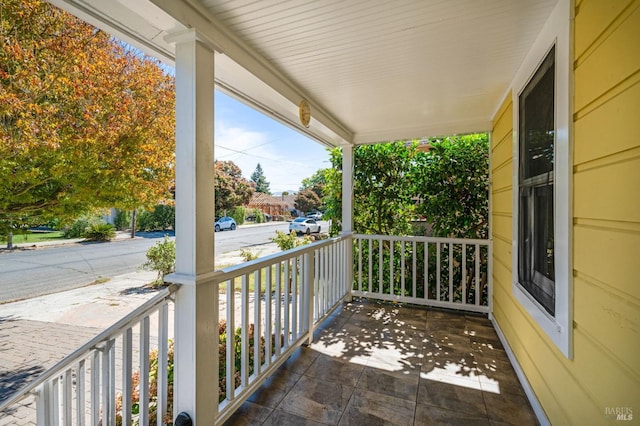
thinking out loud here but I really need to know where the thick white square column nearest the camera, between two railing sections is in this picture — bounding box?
[168,30,218,425]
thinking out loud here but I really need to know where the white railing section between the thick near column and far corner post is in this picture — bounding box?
[212,237,352,423]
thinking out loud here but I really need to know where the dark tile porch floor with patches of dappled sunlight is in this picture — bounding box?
[226,301,538,426]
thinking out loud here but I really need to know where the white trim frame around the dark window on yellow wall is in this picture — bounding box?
[511,0,573,359]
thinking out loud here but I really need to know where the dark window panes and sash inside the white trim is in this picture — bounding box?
[518,47,556,316]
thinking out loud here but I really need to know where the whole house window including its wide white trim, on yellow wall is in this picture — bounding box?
[511,0,573,358]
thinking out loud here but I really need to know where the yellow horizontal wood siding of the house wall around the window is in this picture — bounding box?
[491,0,640,425]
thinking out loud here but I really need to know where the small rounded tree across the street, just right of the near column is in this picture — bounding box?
[215,161,253,212]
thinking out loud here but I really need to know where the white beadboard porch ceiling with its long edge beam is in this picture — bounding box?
[52,0,557,145]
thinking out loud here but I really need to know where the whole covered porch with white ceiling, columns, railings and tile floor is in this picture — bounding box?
[0,0,568,425]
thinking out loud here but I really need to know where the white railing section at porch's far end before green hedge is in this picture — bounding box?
[352,234,492,313]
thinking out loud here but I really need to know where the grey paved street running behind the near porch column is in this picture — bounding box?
[0,222,296,303]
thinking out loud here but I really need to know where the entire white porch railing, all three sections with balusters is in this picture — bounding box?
[0,235,492,425]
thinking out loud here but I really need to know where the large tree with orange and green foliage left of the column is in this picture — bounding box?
[0,0,175,246]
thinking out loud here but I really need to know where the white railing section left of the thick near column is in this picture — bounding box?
[0,286,178,426]
